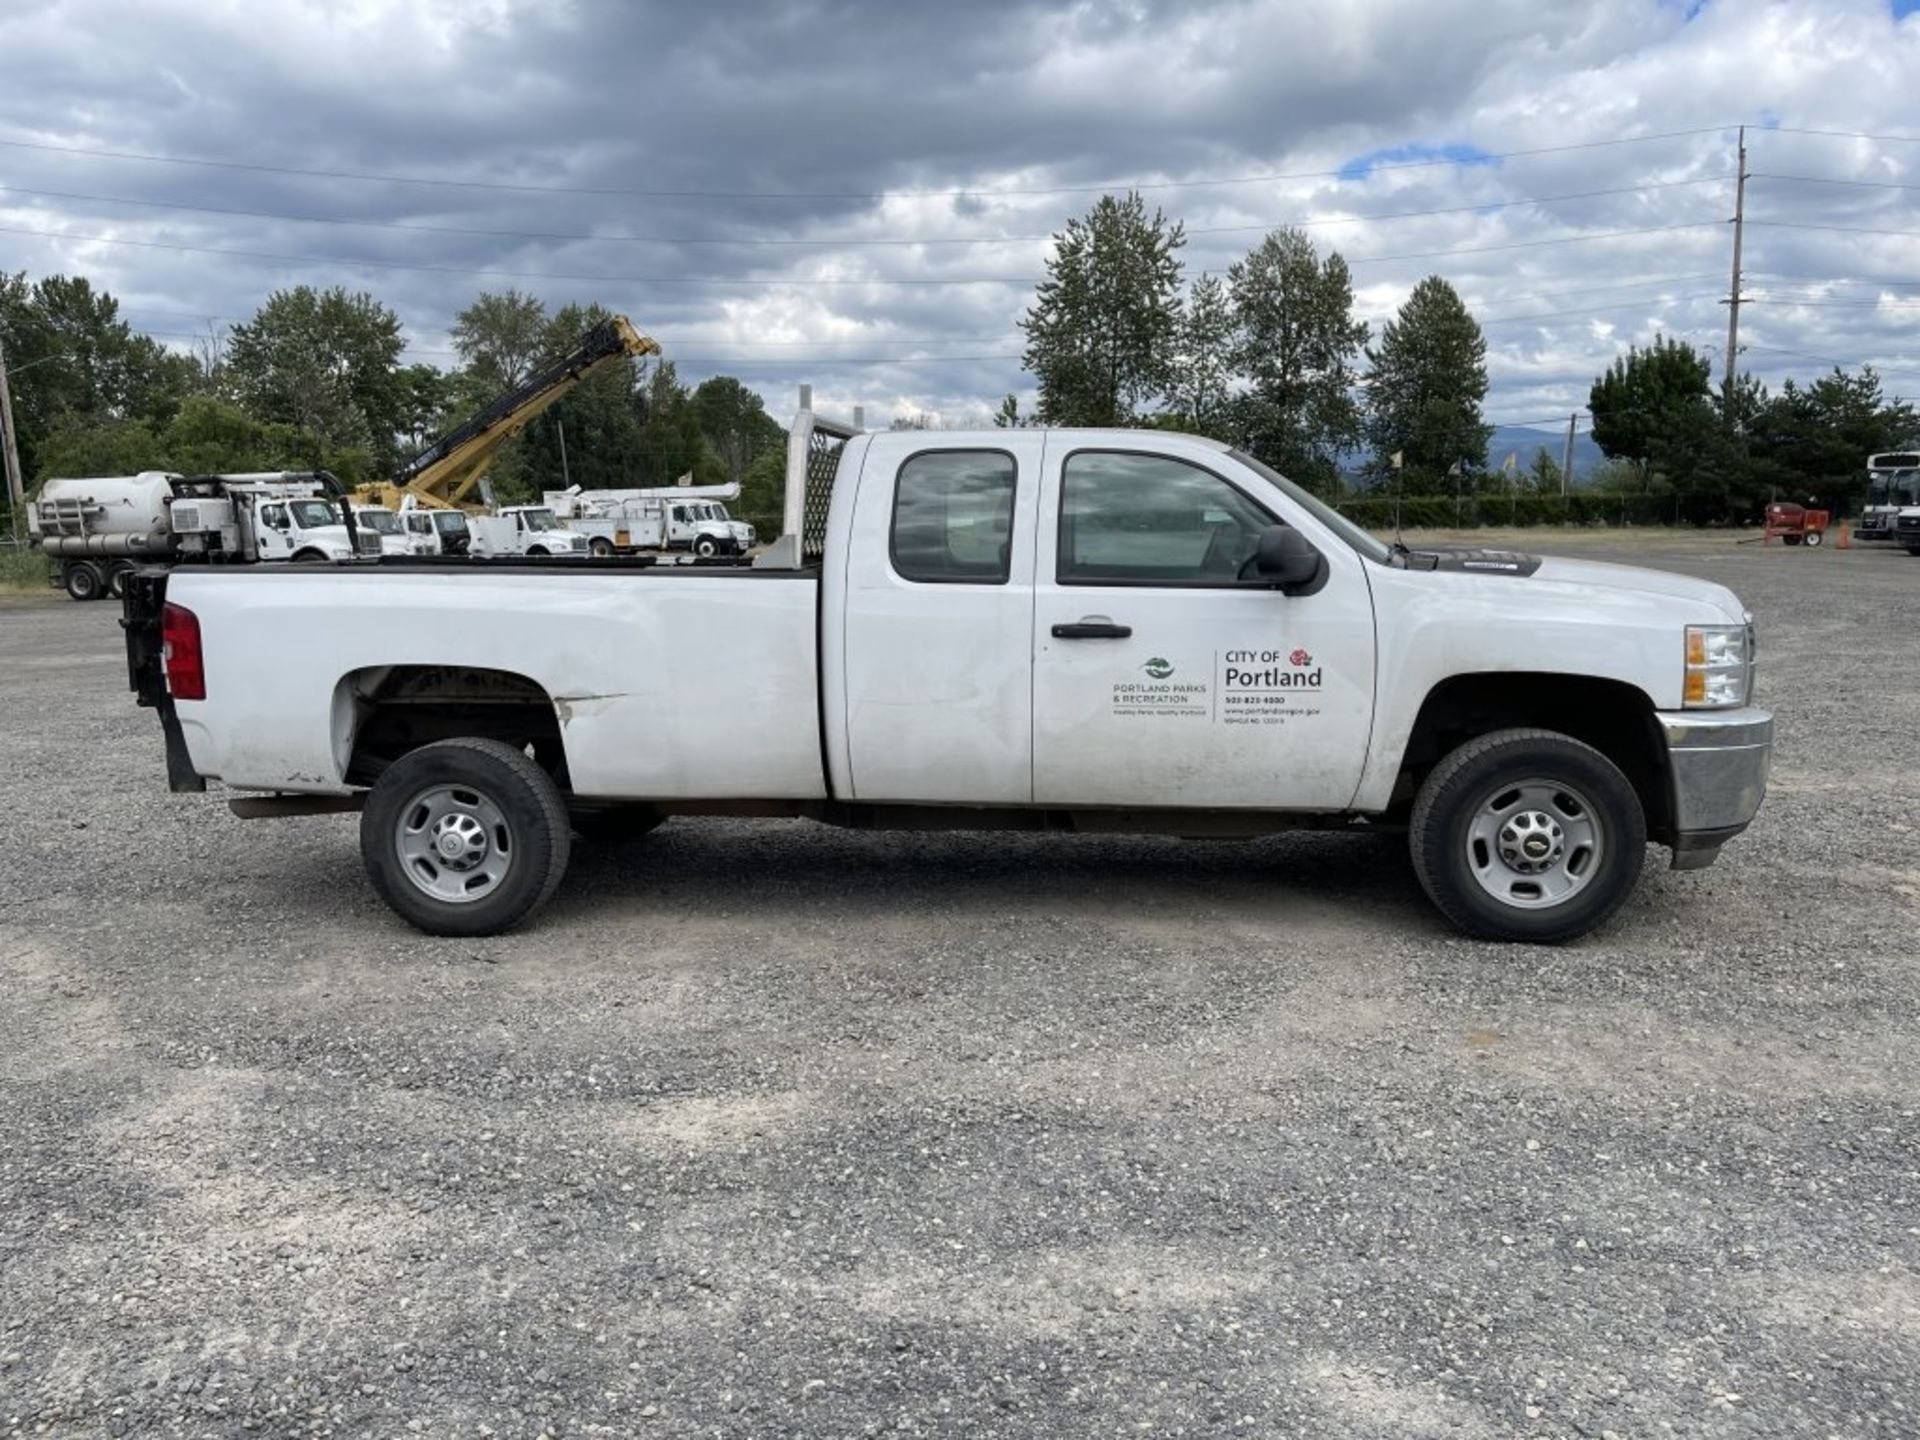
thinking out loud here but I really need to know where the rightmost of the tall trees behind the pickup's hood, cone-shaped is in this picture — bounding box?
[1365,275,1494,493]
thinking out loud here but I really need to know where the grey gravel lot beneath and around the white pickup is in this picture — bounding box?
[0,536,1920,1440]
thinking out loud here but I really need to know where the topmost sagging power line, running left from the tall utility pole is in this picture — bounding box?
[0,125,1728,200]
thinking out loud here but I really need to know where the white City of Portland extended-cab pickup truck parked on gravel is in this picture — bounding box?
[116,411,1772,941]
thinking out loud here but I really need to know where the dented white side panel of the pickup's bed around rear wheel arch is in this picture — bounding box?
[167,566,826,799]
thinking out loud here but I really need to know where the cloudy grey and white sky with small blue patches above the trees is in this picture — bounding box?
[0,0,1920,443]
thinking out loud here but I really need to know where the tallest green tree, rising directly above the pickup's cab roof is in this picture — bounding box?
[1020,192,1187,424]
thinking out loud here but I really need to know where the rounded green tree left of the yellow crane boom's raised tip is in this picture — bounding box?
[227,286,403,468]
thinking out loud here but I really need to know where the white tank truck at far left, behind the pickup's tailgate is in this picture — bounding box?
[27,470,368,601]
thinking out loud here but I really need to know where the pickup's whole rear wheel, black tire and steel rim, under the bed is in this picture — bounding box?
[361,737,572,935]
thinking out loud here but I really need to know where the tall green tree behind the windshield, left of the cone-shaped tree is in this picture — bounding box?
[1227,228,1367,490]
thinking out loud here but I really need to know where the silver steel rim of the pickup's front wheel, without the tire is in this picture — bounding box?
[1465,776,1607,910]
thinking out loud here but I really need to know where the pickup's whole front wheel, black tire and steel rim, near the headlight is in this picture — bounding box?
[1407,730,1647,945]
